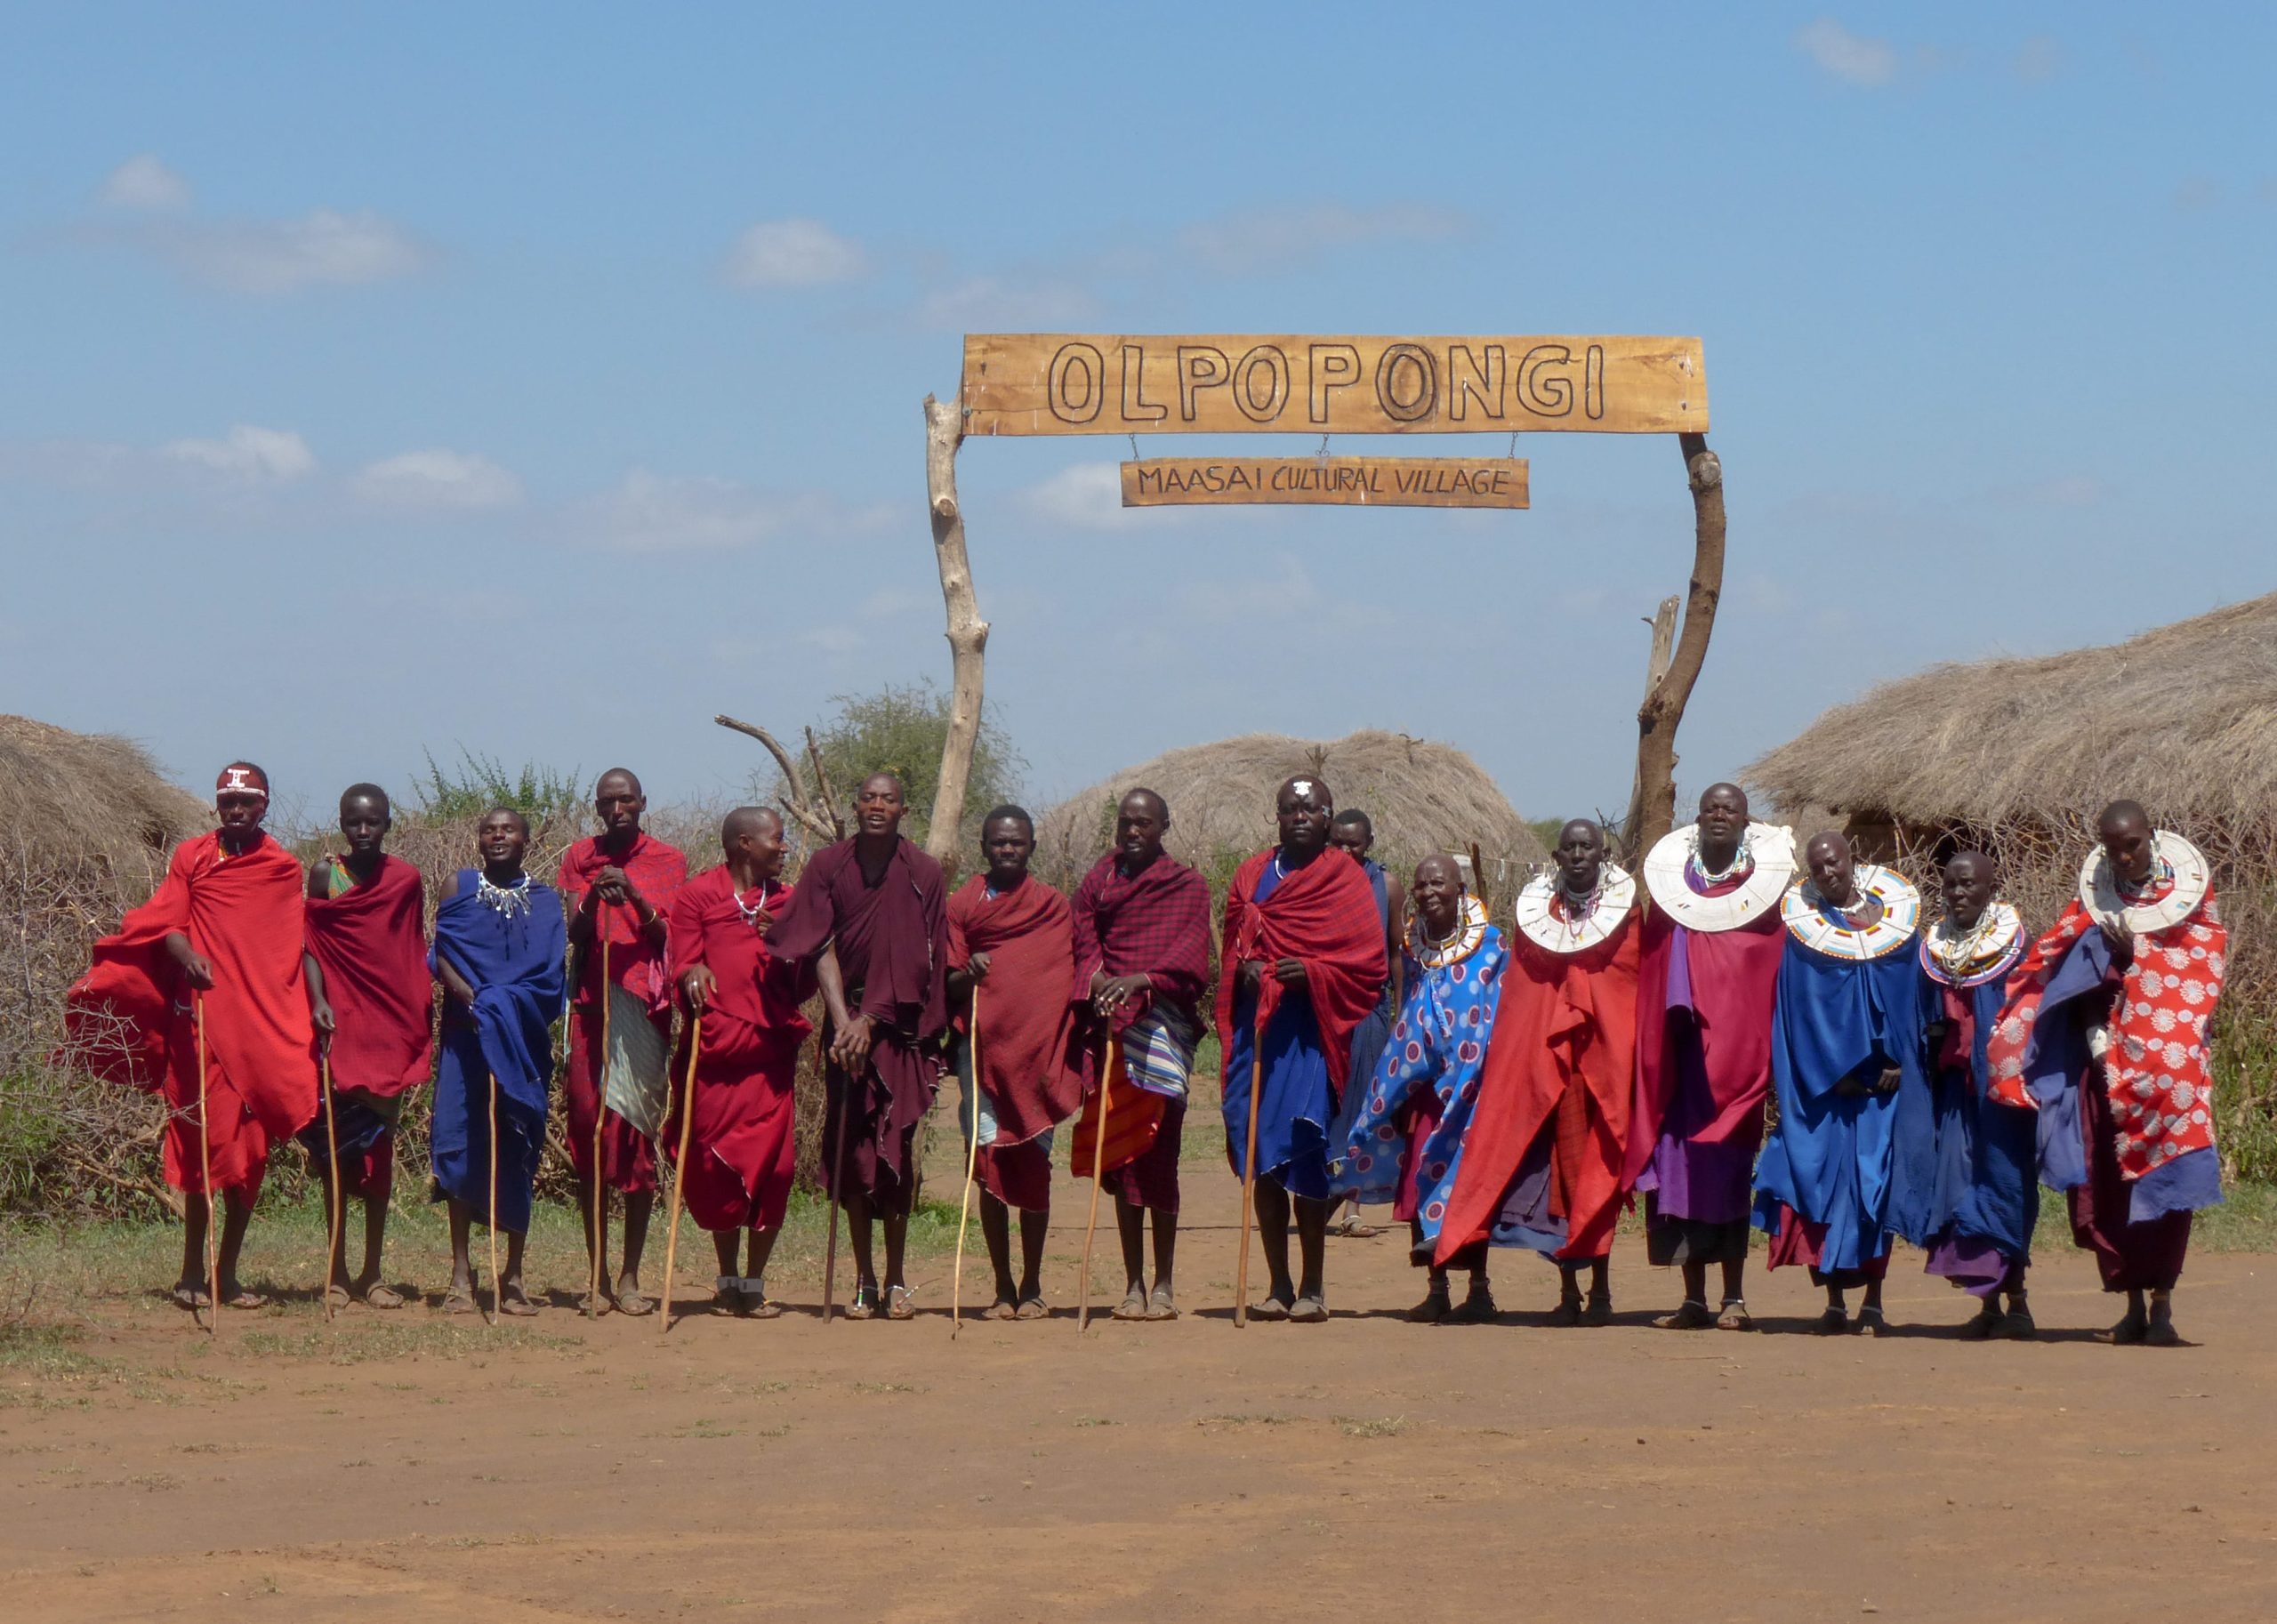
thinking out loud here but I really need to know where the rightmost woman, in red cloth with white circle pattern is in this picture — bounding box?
[1985,801,2229,1348]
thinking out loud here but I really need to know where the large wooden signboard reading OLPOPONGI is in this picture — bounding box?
[963,333,1708,435]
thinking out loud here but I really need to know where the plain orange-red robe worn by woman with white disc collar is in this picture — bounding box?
[1436,906,1644,1264]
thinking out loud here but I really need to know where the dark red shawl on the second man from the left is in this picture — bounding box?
[305,856,435,1100]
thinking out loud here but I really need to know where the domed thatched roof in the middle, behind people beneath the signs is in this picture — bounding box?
[1036,731,1549,874]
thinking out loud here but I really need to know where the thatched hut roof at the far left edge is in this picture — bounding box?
[0,715,212,886]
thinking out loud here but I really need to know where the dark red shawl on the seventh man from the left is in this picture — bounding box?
[950,874,1086,1146]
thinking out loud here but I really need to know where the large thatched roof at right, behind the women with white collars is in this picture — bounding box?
[1744,592,2277,832]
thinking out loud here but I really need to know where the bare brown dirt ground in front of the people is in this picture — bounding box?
[0,1185,2277,1624]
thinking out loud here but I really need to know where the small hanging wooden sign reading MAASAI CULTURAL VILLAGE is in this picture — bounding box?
[1122,458,1525,508]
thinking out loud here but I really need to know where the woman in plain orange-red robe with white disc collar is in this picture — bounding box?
[1436,817,1642,1326]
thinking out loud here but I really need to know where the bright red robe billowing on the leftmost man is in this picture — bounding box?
[64,833,317,1191]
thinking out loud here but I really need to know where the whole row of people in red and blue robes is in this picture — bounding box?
[68,763,2225,1341]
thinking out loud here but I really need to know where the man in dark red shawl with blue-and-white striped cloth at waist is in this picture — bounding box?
[1068,788,1209,1319]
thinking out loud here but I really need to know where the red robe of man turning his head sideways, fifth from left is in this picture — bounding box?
[663,864,815,1233]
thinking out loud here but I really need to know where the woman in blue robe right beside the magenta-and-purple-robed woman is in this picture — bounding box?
[1756,833,1928,1337]
